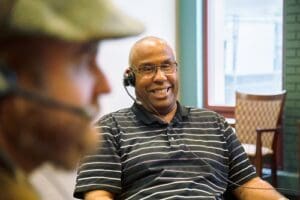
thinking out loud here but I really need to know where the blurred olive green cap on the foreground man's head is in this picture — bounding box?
[0,0,144,41]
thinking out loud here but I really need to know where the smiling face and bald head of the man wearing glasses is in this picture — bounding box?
[132,40,178,115]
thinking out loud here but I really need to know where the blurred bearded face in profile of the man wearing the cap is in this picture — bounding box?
[0,41,110,169]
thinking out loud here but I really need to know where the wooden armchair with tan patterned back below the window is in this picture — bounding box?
[235,91,286,186]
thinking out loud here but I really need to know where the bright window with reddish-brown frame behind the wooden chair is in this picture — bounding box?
[204,0,283,116]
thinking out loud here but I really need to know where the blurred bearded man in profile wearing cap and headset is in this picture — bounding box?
[0,0,143,200]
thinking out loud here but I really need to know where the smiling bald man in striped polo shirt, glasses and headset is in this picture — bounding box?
[74,37,284,200]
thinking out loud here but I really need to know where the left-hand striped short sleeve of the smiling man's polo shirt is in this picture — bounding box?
[74,115,121,198]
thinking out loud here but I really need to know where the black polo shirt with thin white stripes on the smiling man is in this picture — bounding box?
[74,103,256,200]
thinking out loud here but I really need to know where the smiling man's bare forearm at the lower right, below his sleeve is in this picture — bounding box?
[233,177,287,200]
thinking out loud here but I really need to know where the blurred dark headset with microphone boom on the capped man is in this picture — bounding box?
[0,61,96,119]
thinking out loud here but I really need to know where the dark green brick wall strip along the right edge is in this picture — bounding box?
[283,0,300,172]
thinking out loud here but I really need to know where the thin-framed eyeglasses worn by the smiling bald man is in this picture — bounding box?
[131,62,178,76]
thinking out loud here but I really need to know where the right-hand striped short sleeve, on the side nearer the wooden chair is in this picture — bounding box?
[221,117,257,190]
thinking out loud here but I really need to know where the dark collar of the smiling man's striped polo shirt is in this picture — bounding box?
[131,101,190,124]
